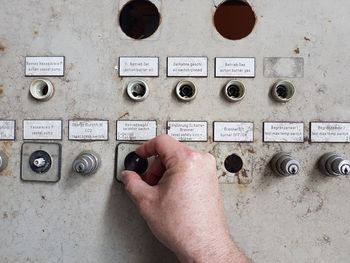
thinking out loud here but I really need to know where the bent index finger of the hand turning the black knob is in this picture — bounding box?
[136,134,186,159]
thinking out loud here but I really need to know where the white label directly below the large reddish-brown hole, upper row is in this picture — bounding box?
[215,58,255,78]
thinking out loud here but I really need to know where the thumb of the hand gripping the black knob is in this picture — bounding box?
[120,171,153,205]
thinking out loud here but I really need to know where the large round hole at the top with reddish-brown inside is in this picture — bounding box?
[214,0,256,40]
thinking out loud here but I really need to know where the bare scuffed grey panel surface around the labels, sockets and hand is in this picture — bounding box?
[0,0,350,263]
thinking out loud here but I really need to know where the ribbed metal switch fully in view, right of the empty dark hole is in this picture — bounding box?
[270,152,300,176]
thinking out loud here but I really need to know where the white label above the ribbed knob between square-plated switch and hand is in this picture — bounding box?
[68,120,108,141]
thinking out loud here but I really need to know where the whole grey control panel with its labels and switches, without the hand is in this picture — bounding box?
[0,0,350,263]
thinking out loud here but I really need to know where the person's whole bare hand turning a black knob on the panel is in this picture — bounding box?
[121,135,248,263]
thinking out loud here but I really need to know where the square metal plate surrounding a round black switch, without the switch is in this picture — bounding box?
[21,142,61,183]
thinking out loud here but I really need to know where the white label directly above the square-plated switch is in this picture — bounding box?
[23,120,62,140]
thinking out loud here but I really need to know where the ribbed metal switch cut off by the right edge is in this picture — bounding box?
[318,153,350,176]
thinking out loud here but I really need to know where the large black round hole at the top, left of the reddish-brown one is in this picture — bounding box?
[119,0,160,39]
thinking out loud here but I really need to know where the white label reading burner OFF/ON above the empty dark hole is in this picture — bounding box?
[214,122,254,142]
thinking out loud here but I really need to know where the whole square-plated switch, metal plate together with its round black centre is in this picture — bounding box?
[21,142,61,183]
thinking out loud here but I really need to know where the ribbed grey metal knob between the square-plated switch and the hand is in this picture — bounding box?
[73,152,101,175]
